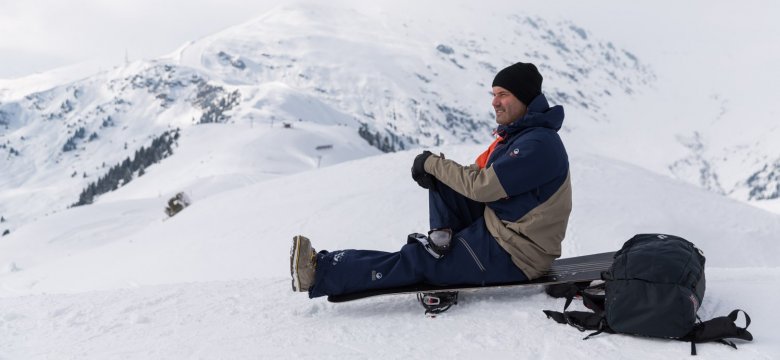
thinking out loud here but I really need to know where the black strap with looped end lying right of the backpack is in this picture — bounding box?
[680,309,753,355]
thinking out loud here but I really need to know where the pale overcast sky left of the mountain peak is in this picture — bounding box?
[0,0,281,78]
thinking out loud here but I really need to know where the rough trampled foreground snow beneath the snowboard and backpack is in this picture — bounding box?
[0,269,780,360]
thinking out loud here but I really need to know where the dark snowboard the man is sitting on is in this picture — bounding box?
[328,252,615,303]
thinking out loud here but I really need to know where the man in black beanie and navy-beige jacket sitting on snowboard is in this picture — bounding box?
[290,63,572,298]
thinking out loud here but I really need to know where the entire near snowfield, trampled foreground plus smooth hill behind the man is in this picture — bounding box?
[0,146,780,359]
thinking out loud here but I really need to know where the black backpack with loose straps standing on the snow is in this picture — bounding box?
[544,234,753,355]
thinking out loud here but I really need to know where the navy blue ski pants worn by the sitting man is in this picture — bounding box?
[309,181,528,298]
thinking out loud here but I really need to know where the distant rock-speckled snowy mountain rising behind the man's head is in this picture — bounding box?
[0,3,655,231]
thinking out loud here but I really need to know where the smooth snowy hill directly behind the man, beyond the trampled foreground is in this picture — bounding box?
[0,147,780,294]
